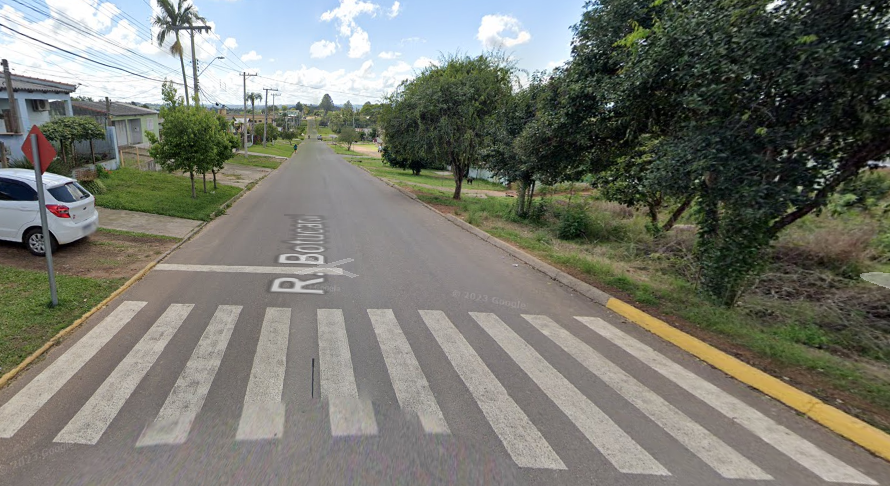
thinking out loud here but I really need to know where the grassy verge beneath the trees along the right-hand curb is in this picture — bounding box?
[398,183,890,431]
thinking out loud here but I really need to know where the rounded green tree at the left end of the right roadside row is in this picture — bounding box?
[384,55,515,199]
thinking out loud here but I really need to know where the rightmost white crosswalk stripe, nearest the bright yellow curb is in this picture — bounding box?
[575,317,878,485]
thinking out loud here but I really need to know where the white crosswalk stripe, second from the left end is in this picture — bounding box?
[54,304,194,444]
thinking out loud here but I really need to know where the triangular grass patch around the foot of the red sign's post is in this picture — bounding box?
[0,266,125,374]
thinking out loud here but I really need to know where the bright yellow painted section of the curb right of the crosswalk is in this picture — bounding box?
[606,298,890,461]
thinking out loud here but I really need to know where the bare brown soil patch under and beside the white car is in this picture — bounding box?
[0,231,177,278]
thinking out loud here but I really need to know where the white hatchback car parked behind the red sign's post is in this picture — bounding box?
[0,169,99,256]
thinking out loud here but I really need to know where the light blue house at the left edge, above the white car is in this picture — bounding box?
[0,74,77,160]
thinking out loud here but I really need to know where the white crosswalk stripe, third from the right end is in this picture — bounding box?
[470,312,670,476]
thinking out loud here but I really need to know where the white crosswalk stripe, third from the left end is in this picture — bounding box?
[136,305,241,447]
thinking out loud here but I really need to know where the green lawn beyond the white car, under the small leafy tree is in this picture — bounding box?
[96,168,241,221]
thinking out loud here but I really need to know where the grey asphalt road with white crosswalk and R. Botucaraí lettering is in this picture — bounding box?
[0,127,890,486]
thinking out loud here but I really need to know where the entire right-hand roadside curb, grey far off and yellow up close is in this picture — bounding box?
[362,167,890,461]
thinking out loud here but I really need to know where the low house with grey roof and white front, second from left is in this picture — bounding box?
[71,101,160,147]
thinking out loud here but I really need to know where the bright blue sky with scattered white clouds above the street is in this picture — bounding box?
[0,0,584,107]
